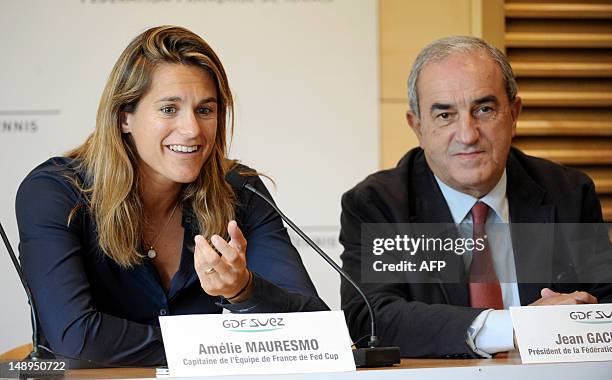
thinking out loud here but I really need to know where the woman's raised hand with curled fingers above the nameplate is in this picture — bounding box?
[194,220,253,302]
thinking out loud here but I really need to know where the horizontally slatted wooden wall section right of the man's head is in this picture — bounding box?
[505,0,612,221]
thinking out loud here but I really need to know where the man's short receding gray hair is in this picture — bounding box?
[408,36,517,119]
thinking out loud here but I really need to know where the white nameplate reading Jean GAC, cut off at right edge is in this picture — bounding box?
[510,304,612,363]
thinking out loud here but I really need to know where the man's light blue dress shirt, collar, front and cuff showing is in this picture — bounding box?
[436,170,521,357]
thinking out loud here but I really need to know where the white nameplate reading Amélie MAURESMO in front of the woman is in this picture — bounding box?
[159,311,355,376]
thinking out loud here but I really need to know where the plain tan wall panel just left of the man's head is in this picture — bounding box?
[379,0,474,168]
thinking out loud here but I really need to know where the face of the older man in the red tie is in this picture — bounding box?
[407,51,521,198]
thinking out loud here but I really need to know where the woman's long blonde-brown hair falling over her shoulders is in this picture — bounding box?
[66,26,235,267]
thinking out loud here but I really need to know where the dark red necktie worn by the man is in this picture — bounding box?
[469,202,504,309]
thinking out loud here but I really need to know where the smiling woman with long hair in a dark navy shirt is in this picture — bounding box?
[16,26,327,366]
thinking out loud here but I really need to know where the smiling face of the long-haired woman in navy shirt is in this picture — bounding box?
[121,63,218,189]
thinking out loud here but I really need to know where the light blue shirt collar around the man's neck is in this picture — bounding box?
[434,169,509,224]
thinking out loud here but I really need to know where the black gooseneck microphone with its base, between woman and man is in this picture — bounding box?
[225,170,400,367]
